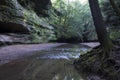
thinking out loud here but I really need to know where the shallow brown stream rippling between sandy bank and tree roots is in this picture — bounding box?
[0,44,91,80]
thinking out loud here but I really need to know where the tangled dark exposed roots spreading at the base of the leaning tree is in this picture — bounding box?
[74,46,120,80]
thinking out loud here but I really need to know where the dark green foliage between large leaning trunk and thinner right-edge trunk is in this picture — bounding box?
[101,0,120,39]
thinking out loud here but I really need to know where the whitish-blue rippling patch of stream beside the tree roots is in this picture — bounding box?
[36,47,89,60]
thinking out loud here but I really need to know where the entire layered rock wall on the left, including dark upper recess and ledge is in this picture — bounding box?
[0,0,55,43]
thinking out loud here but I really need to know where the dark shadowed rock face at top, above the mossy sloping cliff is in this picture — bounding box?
[18,0,52,17]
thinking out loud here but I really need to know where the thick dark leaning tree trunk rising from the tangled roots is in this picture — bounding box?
[89,0,112,55]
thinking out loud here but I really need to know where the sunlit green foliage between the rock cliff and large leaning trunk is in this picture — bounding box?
[49,0,96,41]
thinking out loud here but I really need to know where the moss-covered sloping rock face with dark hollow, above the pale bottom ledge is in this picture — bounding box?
[0,0,55,43]
